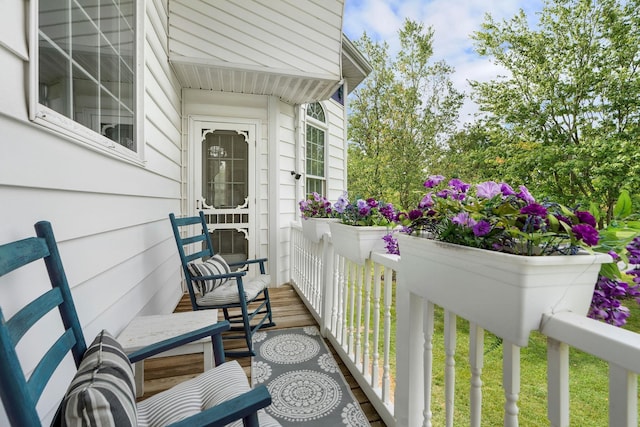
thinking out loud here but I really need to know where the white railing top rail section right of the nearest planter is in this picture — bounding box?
[540,311,640,373]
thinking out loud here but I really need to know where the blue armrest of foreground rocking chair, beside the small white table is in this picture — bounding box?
[127,320,231,364]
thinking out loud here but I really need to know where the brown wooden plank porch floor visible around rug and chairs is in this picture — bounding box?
[142,285,385,427]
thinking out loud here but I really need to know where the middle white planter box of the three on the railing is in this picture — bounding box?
[329,222,390,265]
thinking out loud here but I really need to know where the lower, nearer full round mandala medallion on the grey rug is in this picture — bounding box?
[269,370,342,422]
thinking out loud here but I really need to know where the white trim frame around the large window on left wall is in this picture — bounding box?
[28,0,146,166]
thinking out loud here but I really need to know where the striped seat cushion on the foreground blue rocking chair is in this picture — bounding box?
[138,360,280,427]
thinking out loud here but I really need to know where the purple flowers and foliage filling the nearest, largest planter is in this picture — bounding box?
[398,175,598,255]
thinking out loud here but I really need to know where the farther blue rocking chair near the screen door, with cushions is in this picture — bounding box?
[169,211,275,357]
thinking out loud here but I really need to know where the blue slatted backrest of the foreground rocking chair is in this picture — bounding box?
[0,221,87,426]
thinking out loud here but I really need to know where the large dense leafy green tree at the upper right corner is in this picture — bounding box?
[469,0,640,222]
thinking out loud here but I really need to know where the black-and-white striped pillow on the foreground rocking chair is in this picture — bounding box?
[62,330,137,427]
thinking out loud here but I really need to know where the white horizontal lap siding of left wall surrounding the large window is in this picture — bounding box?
[0,0,182,425]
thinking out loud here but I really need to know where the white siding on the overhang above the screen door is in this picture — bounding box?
[169,0,344,81]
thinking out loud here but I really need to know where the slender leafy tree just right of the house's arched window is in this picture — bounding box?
[348,20,463,208]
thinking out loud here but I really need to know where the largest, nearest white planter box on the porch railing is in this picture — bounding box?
[398,233,612,347]
